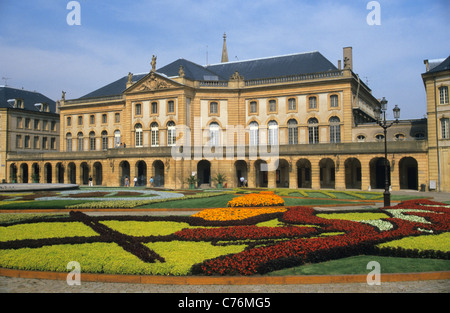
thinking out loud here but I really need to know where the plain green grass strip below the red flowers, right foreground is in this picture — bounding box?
[267,255,450,279]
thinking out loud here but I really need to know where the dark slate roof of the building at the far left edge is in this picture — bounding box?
[0,86,56,113]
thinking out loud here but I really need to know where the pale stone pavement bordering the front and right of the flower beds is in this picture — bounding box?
[0,191,450,293]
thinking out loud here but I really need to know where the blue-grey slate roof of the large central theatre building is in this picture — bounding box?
[81,51,337,99]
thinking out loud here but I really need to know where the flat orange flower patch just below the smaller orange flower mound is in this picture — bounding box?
[193,208,286,221]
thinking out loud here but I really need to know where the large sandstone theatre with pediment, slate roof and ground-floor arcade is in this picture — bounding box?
[4,42,430,190]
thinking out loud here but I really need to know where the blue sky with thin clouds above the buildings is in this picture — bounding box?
[0,0,450,119]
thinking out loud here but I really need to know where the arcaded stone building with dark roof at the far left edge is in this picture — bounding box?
[0,86,60,183]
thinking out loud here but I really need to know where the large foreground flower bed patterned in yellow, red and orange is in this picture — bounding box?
[0,200,450,275]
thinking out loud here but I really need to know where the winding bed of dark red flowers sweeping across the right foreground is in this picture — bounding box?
[194,200,450,275]
